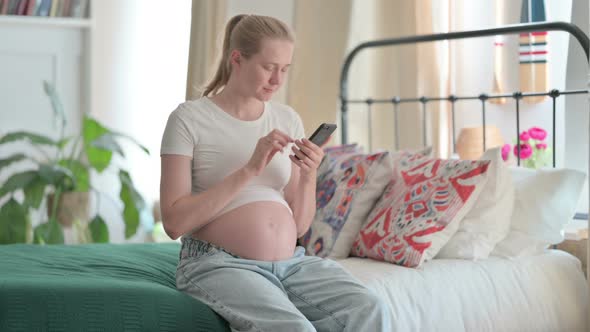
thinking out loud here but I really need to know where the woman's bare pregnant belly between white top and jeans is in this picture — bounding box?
[193,201,297,261]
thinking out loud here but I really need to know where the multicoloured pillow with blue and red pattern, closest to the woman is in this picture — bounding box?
[300,152,392,258]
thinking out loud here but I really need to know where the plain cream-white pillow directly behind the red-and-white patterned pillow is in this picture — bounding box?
[436,148,514,259]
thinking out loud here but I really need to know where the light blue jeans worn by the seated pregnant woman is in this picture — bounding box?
[176,238,391,332]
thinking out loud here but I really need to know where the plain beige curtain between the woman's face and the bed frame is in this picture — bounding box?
[287,0,351,137]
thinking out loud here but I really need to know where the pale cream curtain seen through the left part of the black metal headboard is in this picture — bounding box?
[348,0,450,156]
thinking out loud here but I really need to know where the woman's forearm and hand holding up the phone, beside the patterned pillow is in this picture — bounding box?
[285,139,324,237]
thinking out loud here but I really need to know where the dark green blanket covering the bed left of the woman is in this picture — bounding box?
[0,243,229,331]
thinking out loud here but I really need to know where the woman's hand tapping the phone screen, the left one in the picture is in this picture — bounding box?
[246,129,295,176]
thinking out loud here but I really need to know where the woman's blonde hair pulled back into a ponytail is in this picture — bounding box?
[203,14,295,96]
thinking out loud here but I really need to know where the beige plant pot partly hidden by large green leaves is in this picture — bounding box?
[47,191,90,227]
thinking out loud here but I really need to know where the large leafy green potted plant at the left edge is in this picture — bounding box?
[0,81,149,244]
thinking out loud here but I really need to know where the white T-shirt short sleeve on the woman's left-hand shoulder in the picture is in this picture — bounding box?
[160,109,195,157]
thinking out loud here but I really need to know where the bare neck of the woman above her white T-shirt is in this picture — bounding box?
[211,86,264,121]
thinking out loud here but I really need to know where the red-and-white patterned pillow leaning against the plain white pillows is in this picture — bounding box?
[351,153,490,267]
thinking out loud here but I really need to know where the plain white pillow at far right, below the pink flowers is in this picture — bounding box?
[492,167,586,257]
